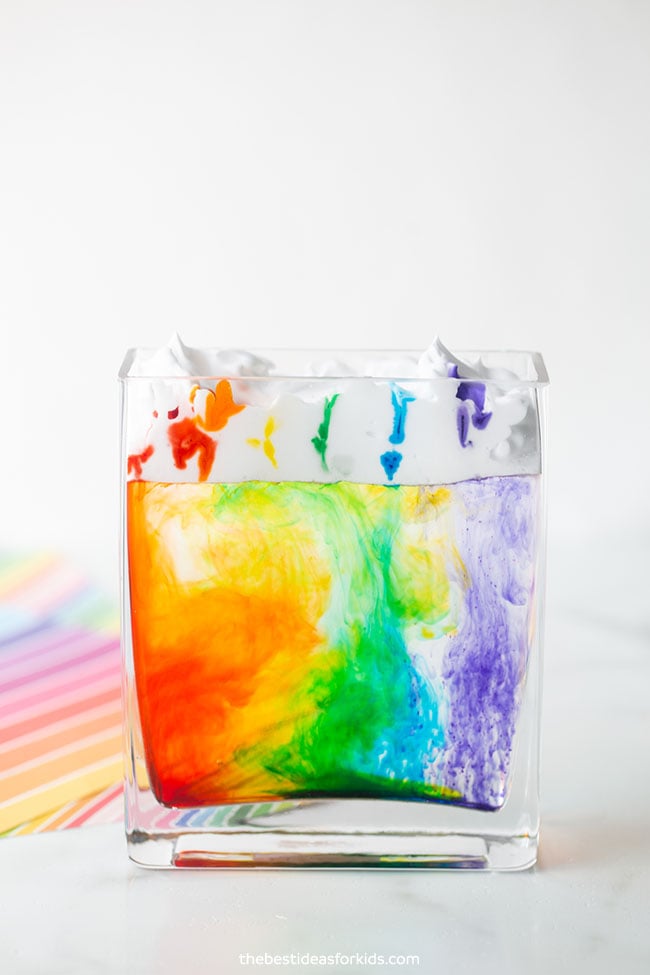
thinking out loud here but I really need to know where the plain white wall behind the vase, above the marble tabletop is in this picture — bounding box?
[0,0,650,592]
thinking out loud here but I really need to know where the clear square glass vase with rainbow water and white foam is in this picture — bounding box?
[120,350,548,870]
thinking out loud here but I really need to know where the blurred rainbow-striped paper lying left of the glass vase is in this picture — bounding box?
[0,553,122,835]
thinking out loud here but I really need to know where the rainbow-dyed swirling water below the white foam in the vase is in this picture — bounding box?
[127,477,538,809]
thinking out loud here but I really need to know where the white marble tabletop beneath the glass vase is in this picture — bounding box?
[0,539,650,975]
